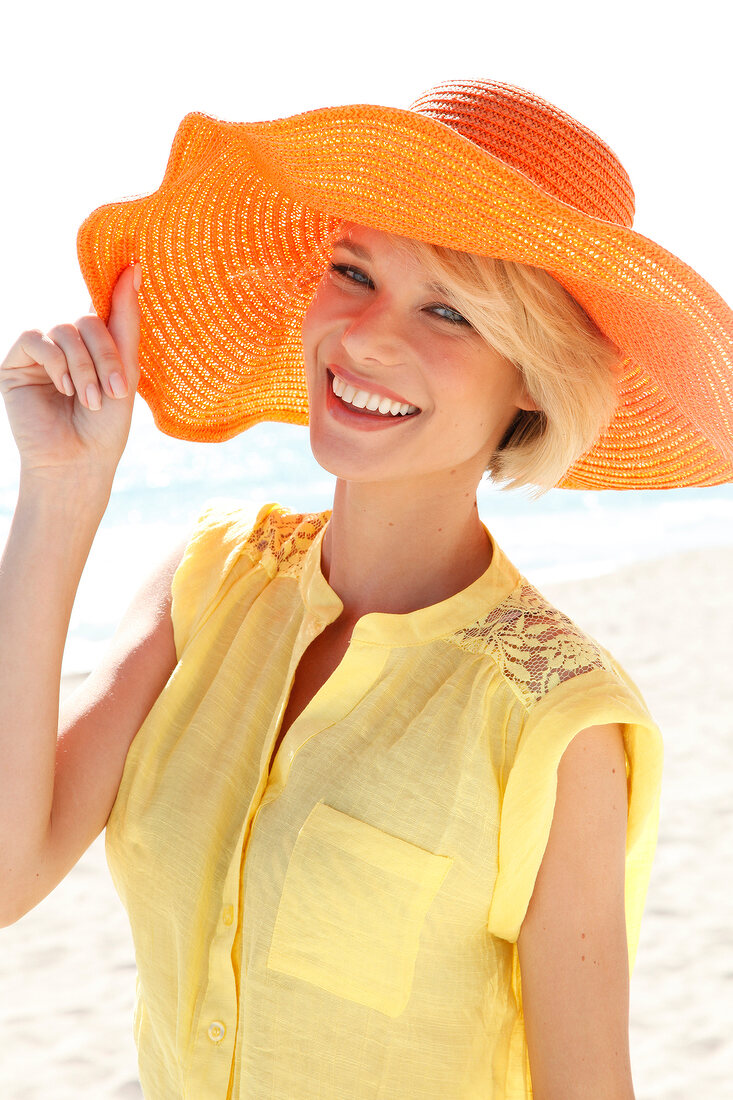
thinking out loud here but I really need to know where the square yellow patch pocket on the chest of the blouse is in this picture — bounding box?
[267,802,453,1016]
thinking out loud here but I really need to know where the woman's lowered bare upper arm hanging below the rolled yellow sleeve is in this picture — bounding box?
[517,725,634,1100]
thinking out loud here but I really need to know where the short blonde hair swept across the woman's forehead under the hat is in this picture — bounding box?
[378,234,622,493]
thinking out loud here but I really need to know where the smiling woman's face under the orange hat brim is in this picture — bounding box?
[303,226,534,486]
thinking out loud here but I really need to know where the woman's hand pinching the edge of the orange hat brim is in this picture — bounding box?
[0,265,140,484]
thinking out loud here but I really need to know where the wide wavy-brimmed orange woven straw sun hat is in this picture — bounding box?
[78,80,733,488]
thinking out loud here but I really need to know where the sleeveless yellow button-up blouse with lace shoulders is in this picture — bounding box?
[107,505,661,1100]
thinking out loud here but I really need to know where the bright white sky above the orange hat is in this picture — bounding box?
[0,0,733,461]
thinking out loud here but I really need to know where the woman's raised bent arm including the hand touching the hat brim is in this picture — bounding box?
[0,268,175,924]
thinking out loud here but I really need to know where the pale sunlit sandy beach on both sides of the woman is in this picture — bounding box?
[0,549,733,1100]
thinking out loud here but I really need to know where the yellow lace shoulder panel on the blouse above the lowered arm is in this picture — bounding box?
[451,580,613,705]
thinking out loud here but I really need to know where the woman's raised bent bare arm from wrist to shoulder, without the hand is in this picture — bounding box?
[0,486,182,926]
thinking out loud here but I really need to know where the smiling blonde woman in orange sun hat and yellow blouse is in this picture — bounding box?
[0,81,733,1100]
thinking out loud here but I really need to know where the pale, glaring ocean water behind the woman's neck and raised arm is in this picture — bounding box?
[0,400,733,672]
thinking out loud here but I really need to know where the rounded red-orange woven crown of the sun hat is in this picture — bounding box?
[411,80,634,227]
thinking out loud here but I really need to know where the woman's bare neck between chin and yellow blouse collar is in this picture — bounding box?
[321,480,491,626]
